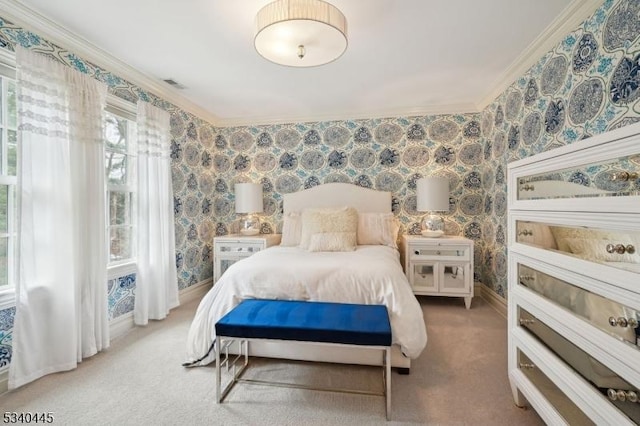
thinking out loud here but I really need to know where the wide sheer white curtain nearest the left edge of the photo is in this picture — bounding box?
[9,47,109,388]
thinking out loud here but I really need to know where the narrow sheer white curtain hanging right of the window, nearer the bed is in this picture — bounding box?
[134,102,179,325]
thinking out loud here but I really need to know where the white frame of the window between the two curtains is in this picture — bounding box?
[105,95,138,280]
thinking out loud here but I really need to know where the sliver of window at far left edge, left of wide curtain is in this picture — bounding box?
[0,69,18,291]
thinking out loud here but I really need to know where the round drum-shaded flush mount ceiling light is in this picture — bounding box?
[254,0,347,67]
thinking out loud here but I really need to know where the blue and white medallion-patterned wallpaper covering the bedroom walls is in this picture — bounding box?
[0,0,640,368]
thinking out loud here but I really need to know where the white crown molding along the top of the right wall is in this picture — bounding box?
[477,0,602,111]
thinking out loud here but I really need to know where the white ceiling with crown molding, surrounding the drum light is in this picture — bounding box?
[8,0,601,125]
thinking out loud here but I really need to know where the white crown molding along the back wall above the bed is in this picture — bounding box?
[219,103,479,127]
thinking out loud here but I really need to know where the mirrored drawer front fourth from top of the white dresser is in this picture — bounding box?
[519,308,640,423]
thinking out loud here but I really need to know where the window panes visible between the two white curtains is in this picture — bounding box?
[105,107,136,265]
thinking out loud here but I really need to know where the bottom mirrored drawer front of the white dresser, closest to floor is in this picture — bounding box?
[518,349,595,425]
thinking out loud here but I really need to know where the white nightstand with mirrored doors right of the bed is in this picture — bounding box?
[403,235,473,309]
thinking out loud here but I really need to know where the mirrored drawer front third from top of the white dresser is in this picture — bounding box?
[518,264,640,349]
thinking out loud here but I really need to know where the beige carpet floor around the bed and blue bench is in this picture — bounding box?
[0,297,543,425]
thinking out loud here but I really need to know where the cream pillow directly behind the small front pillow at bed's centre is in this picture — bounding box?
[300,207,358,249]
